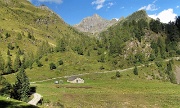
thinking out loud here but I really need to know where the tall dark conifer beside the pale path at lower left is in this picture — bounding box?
[11,66,30,101]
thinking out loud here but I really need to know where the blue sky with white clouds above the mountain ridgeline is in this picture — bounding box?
[28,0,180,25]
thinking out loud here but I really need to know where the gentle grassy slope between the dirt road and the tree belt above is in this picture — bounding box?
[5,51,111,83]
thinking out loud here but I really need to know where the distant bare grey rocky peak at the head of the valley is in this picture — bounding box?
[74,14,118,33]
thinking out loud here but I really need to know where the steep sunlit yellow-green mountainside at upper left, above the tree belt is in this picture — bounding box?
[0,0,93,55]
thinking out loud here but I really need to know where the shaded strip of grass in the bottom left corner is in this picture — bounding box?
[0,96,38,108]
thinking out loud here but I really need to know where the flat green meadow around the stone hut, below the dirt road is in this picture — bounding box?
[34,62,180,108]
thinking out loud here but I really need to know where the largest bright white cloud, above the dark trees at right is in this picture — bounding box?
[148,8,177,23]
